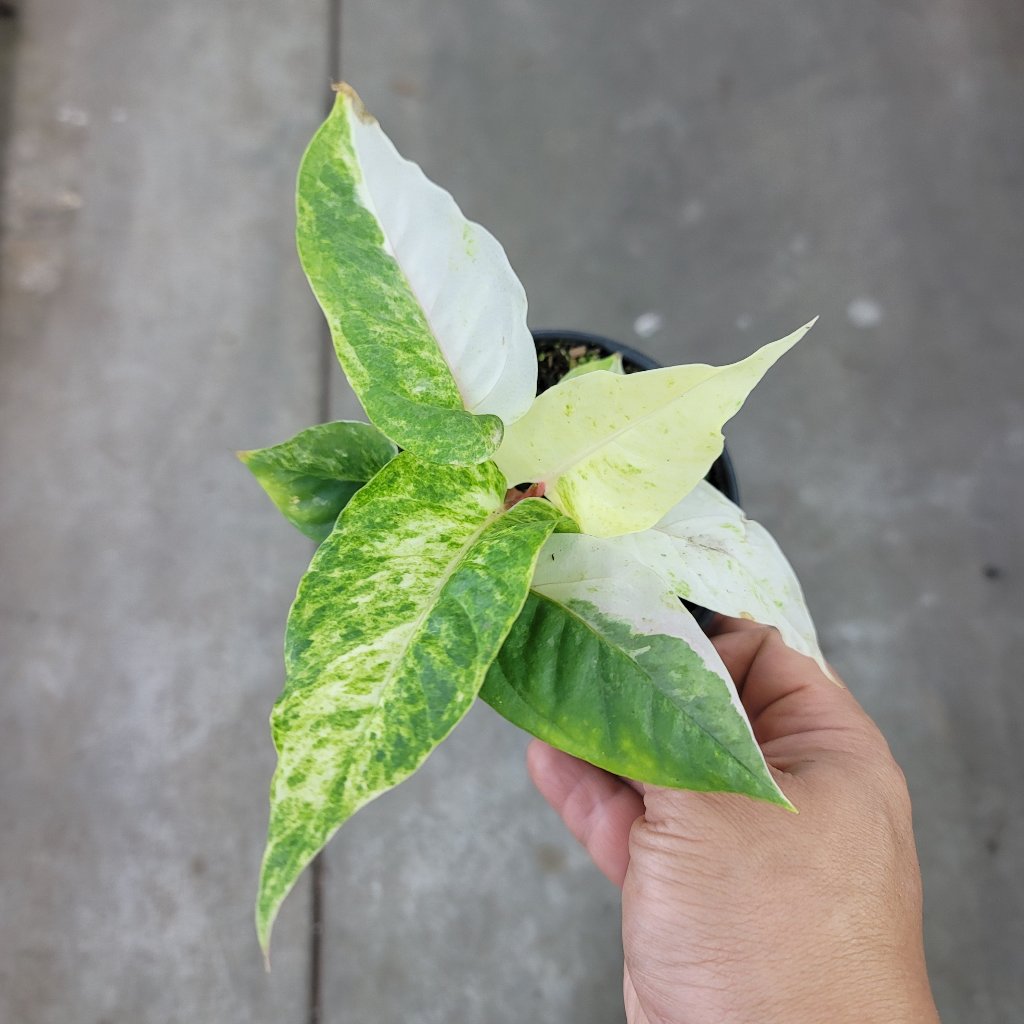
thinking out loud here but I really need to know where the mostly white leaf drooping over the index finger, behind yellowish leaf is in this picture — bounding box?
[623,481,835,678]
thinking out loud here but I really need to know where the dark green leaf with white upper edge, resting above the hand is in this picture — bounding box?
[480,534,790,807]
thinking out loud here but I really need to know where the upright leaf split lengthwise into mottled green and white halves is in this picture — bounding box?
[297,85,537,464]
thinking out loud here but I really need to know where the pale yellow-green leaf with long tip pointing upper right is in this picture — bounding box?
[495,321,813,537]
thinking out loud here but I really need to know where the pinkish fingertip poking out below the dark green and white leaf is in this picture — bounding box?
[526,739,643,887]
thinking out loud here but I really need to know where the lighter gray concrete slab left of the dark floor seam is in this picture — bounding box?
[0,0,324,1024]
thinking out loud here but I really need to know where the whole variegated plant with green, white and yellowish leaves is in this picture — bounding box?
[241,86,821,950]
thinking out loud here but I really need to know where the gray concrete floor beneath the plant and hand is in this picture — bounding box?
[0,0,1024,1024]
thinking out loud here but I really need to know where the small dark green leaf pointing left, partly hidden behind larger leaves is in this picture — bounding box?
[238,420,398,541]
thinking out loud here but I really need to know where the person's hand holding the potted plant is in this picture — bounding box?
[527,620,939,1024]
